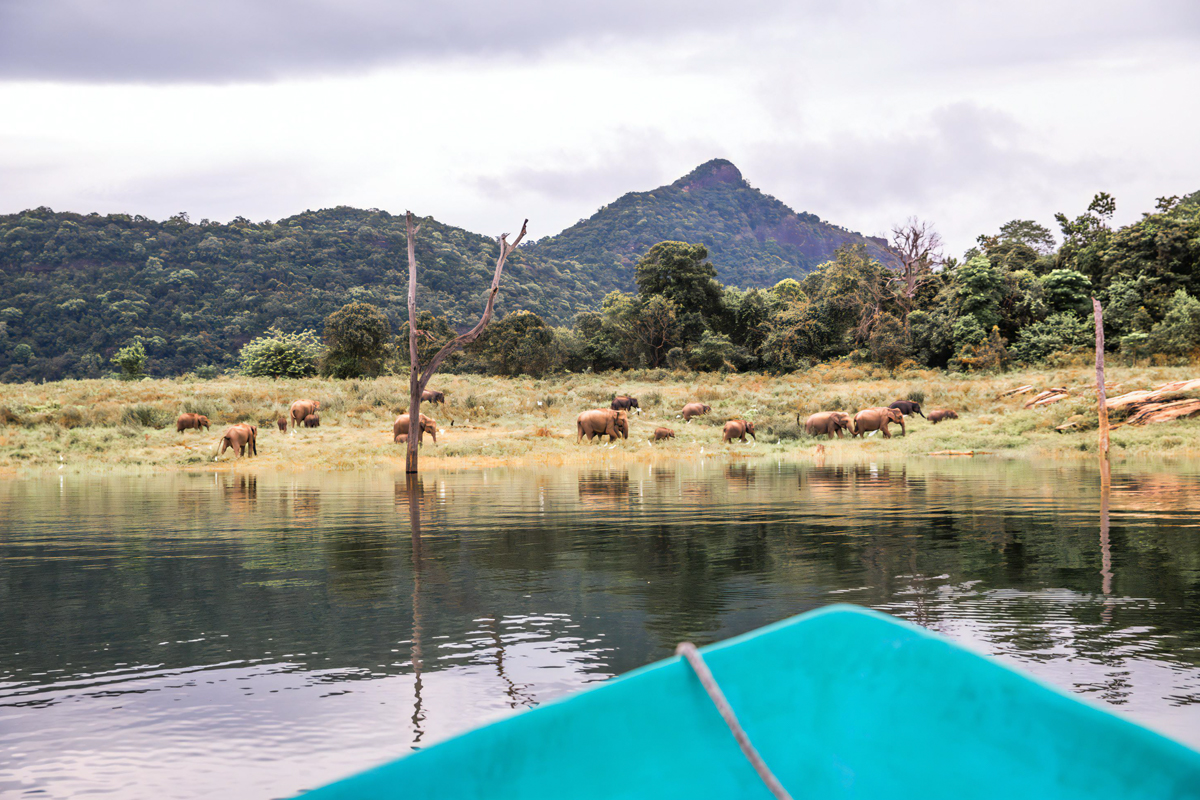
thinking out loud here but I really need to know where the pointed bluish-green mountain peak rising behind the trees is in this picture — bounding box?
[532,158,884,290]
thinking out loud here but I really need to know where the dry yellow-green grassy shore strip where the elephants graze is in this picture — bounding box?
[0,365,1200,475]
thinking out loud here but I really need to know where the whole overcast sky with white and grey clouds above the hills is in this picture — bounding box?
[0,0,1200,252]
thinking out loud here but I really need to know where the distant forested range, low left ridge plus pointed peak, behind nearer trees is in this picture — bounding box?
[0,162,877,381]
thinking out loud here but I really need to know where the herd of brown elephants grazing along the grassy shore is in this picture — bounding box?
[175,390,959,461]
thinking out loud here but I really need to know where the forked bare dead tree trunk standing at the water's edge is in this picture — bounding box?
[404,211,529,474]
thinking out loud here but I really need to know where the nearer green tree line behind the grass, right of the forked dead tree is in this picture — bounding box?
[453,192,1200,374]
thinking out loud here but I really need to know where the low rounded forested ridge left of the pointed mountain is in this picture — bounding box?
[0,207,600,381]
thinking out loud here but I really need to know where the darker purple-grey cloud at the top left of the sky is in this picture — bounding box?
[0,0,796,82]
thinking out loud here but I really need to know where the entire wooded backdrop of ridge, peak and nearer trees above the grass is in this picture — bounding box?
[0,162,1200,381]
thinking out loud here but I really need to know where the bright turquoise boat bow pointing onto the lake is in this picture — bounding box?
[302,606,1200,800]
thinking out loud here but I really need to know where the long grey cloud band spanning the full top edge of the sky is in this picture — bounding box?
[0,0,1200,83]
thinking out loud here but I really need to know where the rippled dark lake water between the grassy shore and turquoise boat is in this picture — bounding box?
[0,456,1200,798]
